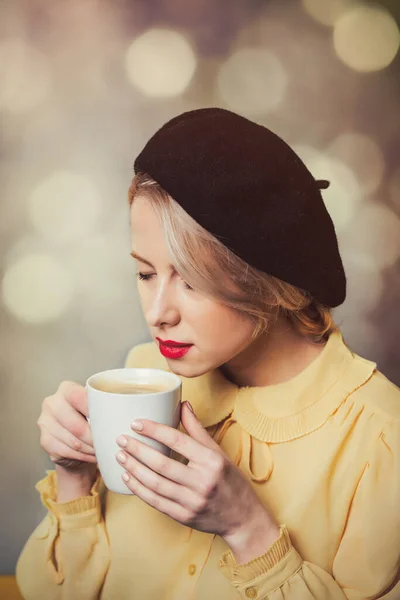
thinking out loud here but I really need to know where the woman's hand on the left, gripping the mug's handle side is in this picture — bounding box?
[37,381,97,474]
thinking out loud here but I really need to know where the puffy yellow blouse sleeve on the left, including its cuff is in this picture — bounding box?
[16,471,110,600]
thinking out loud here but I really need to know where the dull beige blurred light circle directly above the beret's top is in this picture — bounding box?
[217,48,288,116]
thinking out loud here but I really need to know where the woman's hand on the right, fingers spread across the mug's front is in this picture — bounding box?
[117,402,274,539]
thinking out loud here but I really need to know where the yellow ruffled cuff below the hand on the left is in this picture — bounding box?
[35,470,104,528]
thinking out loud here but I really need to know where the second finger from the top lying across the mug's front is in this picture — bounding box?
[117,435,202,492]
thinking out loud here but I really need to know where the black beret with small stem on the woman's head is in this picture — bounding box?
[134,108,346,307]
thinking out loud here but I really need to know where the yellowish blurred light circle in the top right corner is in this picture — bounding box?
[333,4,400,72]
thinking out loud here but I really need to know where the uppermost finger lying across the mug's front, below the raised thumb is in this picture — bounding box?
[131,419,215,465]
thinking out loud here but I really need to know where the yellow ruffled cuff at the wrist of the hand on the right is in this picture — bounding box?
[218,525,303,600]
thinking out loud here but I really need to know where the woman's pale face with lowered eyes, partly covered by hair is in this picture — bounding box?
[131,196,254,377]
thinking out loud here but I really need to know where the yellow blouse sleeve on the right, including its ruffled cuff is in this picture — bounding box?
[218,421,400,600]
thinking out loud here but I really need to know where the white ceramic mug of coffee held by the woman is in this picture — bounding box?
[86,368,182,494]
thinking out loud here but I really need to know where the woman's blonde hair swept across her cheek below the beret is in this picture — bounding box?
[128,173,338,343]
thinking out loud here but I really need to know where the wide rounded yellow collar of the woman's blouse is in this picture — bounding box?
[137,330,376,443]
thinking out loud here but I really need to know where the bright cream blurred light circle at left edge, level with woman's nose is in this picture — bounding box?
[2,254,73,323]
